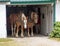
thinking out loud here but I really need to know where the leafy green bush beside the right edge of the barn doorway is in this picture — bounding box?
[50,22,60,38]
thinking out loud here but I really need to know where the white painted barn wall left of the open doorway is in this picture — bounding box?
[0,4,7,38]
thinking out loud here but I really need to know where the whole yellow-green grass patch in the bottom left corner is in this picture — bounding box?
[0,38,18,46]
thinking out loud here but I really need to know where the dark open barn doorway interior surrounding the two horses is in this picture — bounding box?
[6,4,52,36]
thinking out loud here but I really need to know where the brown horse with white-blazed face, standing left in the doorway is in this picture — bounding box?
[10,12,26,37]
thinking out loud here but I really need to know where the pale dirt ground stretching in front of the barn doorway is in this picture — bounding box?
[0,36,60,46]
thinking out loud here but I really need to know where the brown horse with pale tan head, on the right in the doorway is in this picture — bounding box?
[27,12,38,36]
